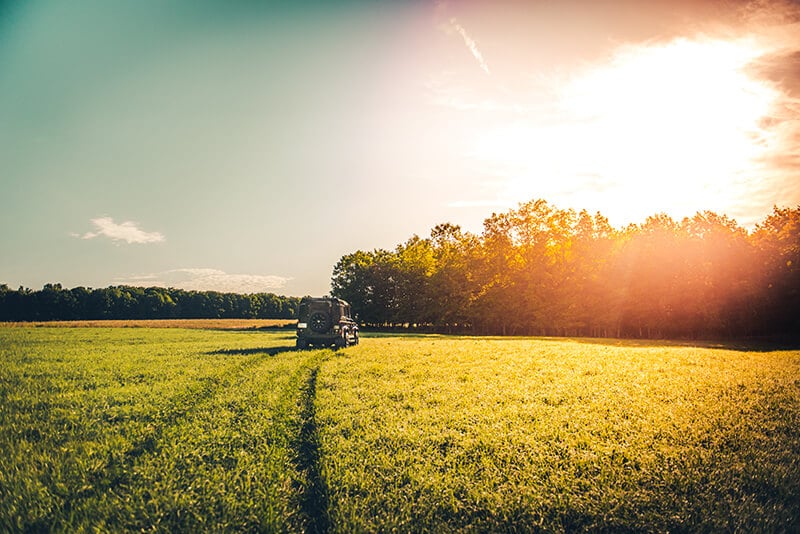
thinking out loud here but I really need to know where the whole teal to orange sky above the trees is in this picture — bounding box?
[0,0,800,296]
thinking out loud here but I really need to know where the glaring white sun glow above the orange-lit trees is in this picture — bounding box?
[475,35,777,222]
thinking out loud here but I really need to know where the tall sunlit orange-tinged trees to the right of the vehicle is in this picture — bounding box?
[332,200,800,338]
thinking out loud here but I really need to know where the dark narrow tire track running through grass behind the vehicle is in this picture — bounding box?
[293,358,330,534]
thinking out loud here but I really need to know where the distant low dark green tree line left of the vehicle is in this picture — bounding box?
[0,284,300,321]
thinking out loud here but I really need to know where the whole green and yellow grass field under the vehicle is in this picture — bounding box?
[0,327,800,532]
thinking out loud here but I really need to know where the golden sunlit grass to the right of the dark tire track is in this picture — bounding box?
[318,337,800,532]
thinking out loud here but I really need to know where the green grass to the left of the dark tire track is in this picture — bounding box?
[0,329,320,531]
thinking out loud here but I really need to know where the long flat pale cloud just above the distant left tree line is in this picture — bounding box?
[117,268,291,293]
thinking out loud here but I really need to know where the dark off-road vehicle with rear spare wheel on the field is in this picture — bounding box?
[297,297,358,349]
